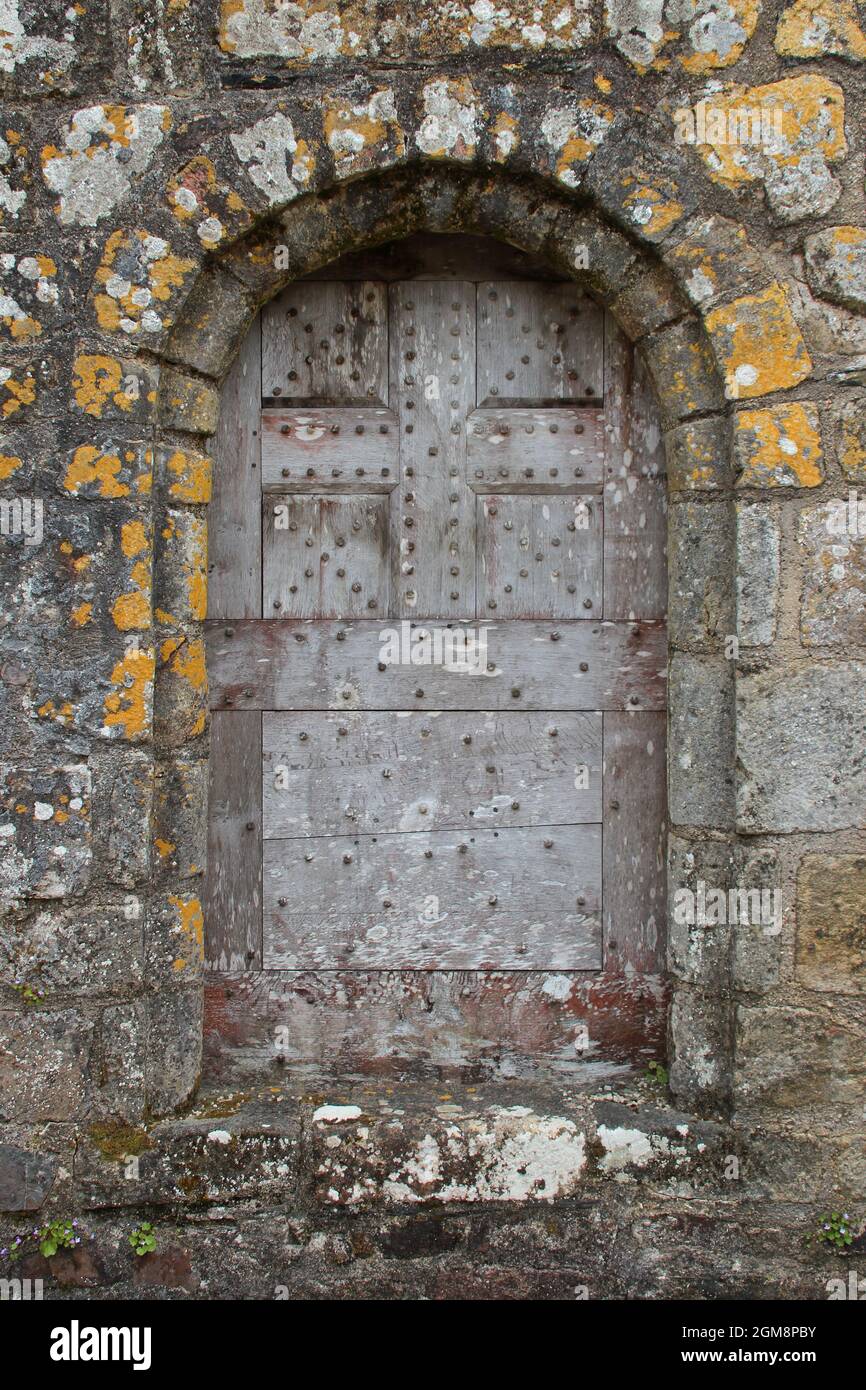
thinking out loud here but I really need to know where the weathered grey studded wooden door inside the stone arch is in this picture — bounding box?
[206,239,666,1068]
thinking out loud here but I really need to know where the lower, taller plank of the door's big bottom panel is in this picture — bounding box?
[263,824,602,970]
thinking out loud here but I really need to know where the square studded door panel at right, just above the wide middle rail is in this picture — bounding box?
[477,496,602,619]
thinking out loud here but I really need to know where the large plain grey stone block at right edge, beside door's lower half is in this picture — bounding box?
[737,662,866,834]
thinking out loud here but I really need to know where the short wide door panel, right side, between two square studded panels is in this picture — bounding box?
[466,406,605,493]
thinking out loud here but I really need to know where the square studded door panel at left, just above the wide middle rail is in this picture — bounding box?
[261,492,389,617]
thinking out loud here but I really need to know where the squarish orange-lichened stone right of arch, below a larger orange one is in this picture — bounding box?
[734,400,824,488]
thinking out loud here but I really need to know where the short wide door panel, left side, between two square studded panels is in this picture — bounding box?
[261,406,398,492]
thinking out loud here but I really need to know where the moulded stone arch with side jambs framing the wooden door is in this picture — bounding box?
[147,165,734,1111]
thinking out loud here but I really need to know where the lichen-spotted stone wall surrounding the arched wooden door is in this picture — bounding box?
[0,0,866,1297]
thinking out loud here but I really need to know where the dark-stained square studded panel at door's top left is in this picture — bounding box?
[261,281,388,406]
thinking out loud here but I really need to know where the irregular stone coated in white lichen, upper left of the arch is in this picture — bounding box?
[42,106,171,227]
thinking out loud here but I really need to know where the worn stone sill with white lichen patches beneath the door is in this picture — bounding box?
[74,1077,737,1211]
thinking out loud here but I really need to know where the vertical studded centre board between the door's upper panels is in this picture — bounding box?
[389,281,475,619]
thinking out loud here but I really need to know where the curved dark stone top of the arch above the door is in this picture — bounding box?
[163,160,724,432]
